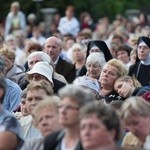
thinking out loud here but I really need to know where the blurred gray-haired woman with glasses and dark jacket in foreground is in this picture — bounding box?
[45,85,94,150]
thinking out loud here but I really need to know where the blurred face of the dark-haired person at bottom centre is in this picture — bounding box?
[80,114,114,149]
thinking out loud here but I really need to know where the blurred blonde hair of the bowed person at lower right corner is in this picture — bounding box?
[121,96,150,123]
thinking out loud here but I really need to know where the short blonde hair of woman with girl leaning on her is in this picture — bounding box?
[106,58,128,77]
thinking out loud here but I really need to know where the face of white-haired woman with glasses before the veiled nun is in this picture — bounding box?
[86,62,101,79]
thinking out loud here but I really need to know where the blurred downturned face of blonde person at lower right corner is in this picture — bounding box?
[127,114,150,142]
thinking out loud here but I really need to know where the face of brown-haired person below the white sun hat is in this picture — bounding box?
[26,89,47,114]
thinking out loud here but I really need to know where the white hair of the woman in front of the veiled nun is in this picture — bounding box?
[86,52,106,67]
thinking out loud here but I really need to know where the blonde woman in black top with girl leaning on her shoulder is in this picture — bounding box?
[99,59,127,103]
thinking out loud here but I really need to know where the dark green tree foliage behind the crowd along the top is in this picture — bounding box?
[0,0,150,21]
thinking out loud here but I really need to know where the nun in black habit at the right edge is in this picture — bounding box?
[128,36,150,86]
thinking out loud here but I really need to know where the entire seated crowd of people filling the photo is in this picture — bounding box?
[0,1,150,150]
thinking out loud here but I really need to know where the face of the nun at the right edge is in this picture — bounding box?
[137,45,150,60]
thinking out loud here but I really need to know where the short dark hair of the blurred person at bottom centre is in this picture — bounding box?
[80,101,121,142]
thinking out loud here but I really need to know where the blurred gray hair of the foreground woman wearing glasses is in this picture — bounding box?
[58,84,95,107]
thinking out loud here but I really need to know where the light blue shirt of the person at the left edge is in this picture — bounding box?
[3,79,22,112]
